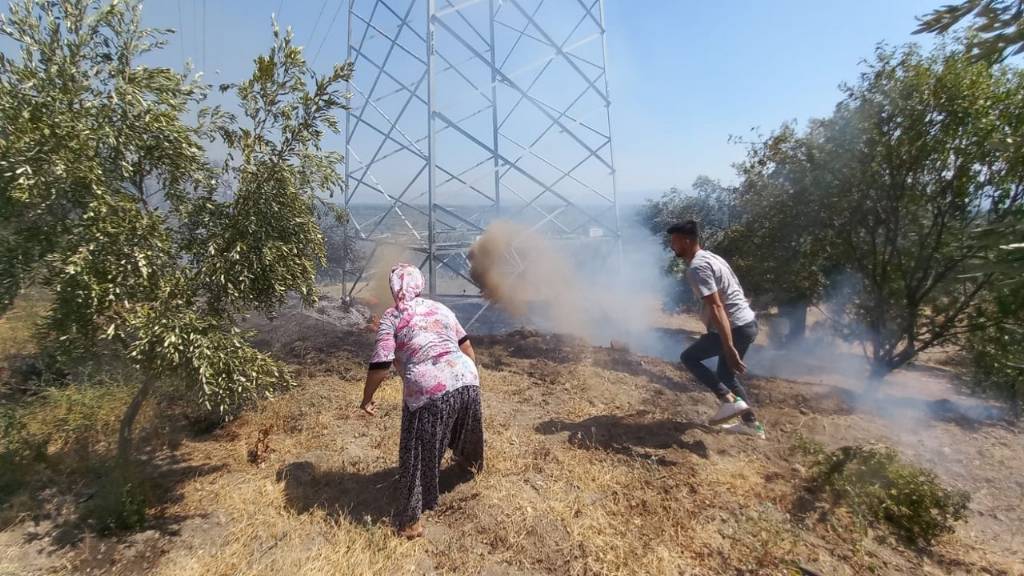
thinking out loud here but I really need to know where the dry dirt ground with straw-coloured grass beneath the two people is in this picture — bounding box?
[0,312,1024,576]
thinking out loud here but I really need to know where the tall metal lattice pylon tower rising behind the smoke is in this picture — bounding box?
[344,0,620,296]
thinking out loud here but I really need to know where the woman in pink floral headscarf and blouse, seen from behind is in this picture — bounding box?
[360,264,483,539]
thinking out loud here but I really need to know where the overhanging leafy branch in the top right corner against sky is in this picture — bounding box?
[914,0,1024,60]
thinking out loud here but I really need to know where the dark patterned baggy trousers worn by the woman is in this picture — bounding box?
[392,385,483,529]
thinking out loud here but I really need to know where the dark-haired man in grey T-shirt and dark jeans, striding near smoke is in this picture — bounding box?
[668,220,765,440]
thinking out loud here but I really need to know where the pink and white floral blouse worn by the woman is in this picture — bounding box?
[370,297,480,410]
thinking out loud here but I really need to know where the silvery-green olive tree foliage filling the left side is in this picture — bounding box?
[0,0,351,423]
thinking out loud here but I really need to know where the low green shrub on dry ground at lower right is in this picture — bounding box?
[811,446,970,546]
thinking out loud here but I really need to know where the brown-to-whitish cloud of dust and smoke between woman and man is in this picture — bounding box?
[469,220,667,348]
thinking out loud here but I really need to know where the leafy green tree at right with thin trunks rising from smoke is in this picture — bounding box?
[810,46,1024,376]
